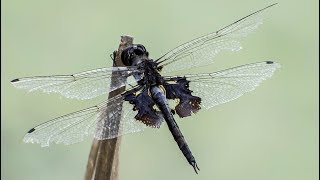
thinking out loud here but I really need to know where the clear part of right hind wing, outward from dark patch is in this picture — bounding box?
[182,61,280,109]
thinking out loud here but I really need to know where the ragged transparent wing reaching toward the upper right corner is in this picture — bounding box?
[156,4,276,73]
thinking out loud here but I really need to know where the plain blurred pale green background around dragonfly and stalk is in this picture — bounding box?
[1,0,319,180]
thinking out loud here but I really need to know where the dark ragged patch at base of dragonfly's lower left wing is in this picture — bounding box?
[123,89,163,128]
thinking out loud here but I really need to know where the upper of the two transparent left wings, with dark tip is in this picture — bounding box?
[11,67,137,99]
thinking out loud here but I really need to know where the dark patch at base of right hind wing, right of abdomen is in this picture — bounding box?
[163,77,201,118]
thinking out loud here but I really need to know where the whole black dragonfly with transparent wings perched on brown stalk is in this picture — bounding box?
[11,4,280,173]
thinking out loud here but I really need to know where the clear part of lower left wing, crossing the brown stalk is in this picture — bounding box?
[23,94,145,147]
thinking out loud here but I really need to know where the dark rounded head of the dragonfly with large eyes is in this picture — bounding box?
[121,44,149,66]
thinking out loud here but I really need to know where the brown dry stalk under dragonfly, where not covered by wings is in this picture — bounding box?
[84,36,133,180]
